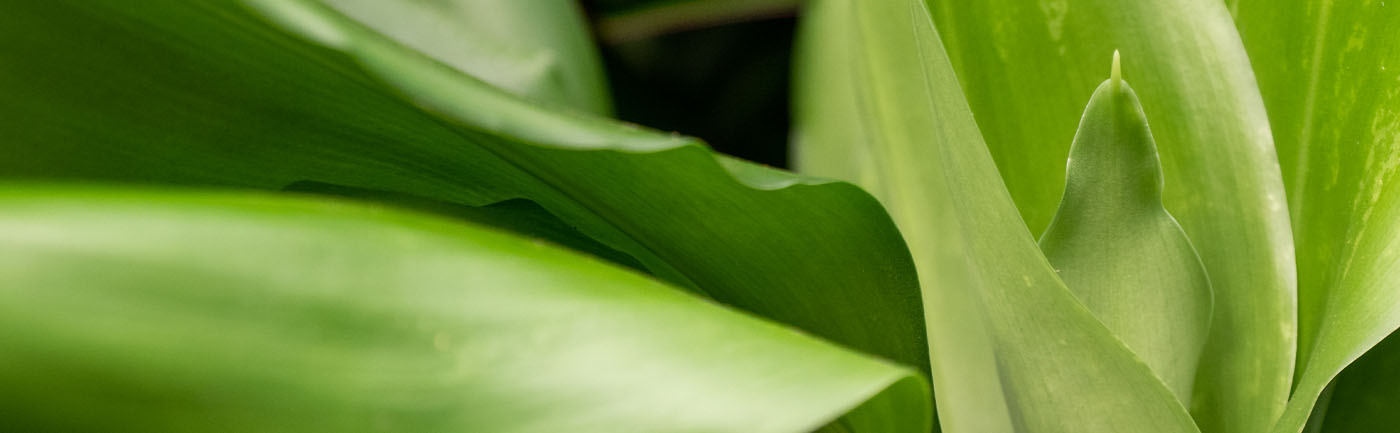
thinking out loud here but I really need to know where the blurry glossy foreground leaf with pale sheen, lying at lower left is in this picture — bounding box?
[0,185,930,433]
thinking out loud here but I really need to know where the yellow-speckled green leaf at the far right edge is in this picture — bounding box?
[1233,1,1400,432]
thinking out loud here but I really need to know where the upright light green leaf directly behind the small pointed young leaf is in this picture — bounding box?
[930,0,1296,433]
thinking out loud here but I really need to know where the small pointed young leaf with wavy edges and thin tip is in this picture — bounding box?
[1040,52,1211,405]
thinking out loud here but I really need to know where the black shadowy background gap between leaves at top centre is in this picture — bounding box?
[582,0,797,168]
